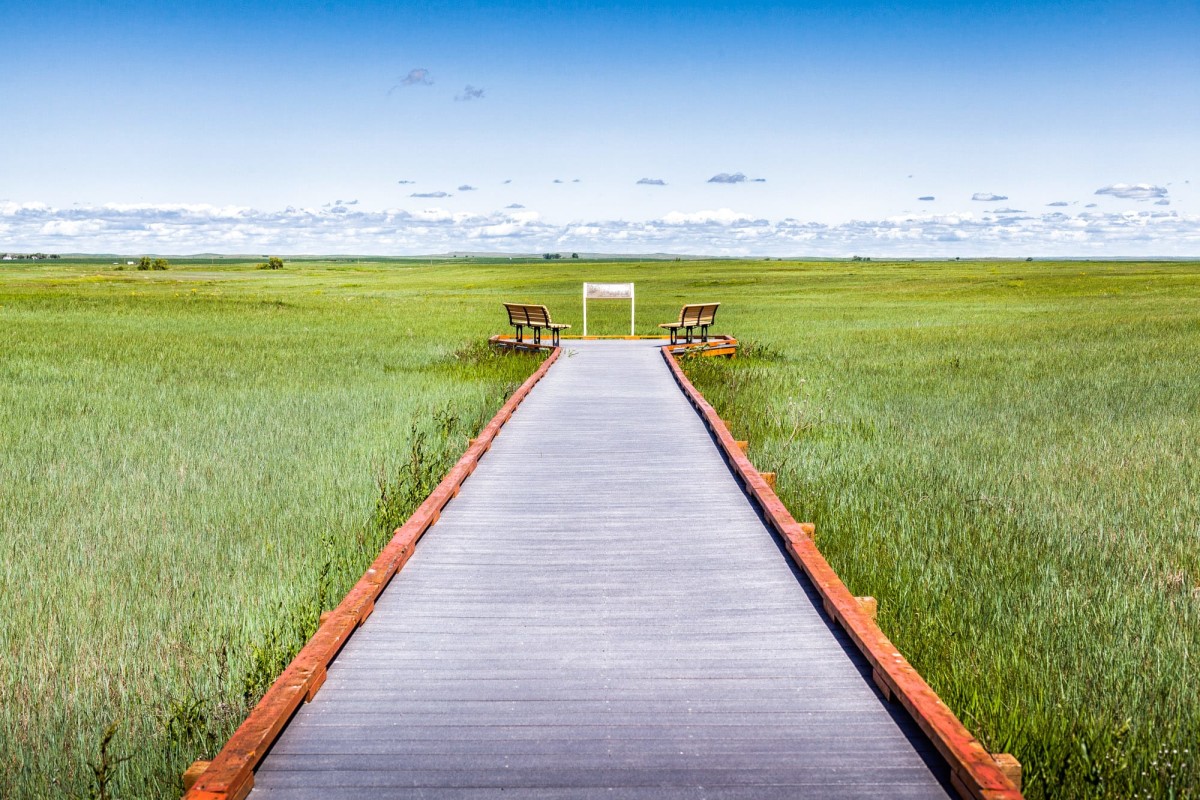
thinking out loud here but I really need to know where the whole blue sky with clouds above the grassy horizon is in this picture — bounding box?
[0,0,1200,255]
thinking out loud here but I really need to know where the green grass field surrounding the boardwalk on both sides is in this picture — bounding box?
[0,259,1200,798]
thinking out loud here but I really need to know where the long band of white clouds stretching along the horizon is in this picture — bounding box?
[0,201,1200,257]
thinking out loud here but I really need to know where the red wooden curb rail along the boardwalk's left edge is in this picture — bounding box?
[184,348,559,800]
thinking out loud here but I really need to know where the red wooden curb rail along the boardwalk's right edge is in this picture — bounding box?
[662,347,1021,800]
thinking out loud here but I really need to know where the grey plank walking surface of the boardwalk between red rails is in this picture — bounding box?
[251,341,946,800]
